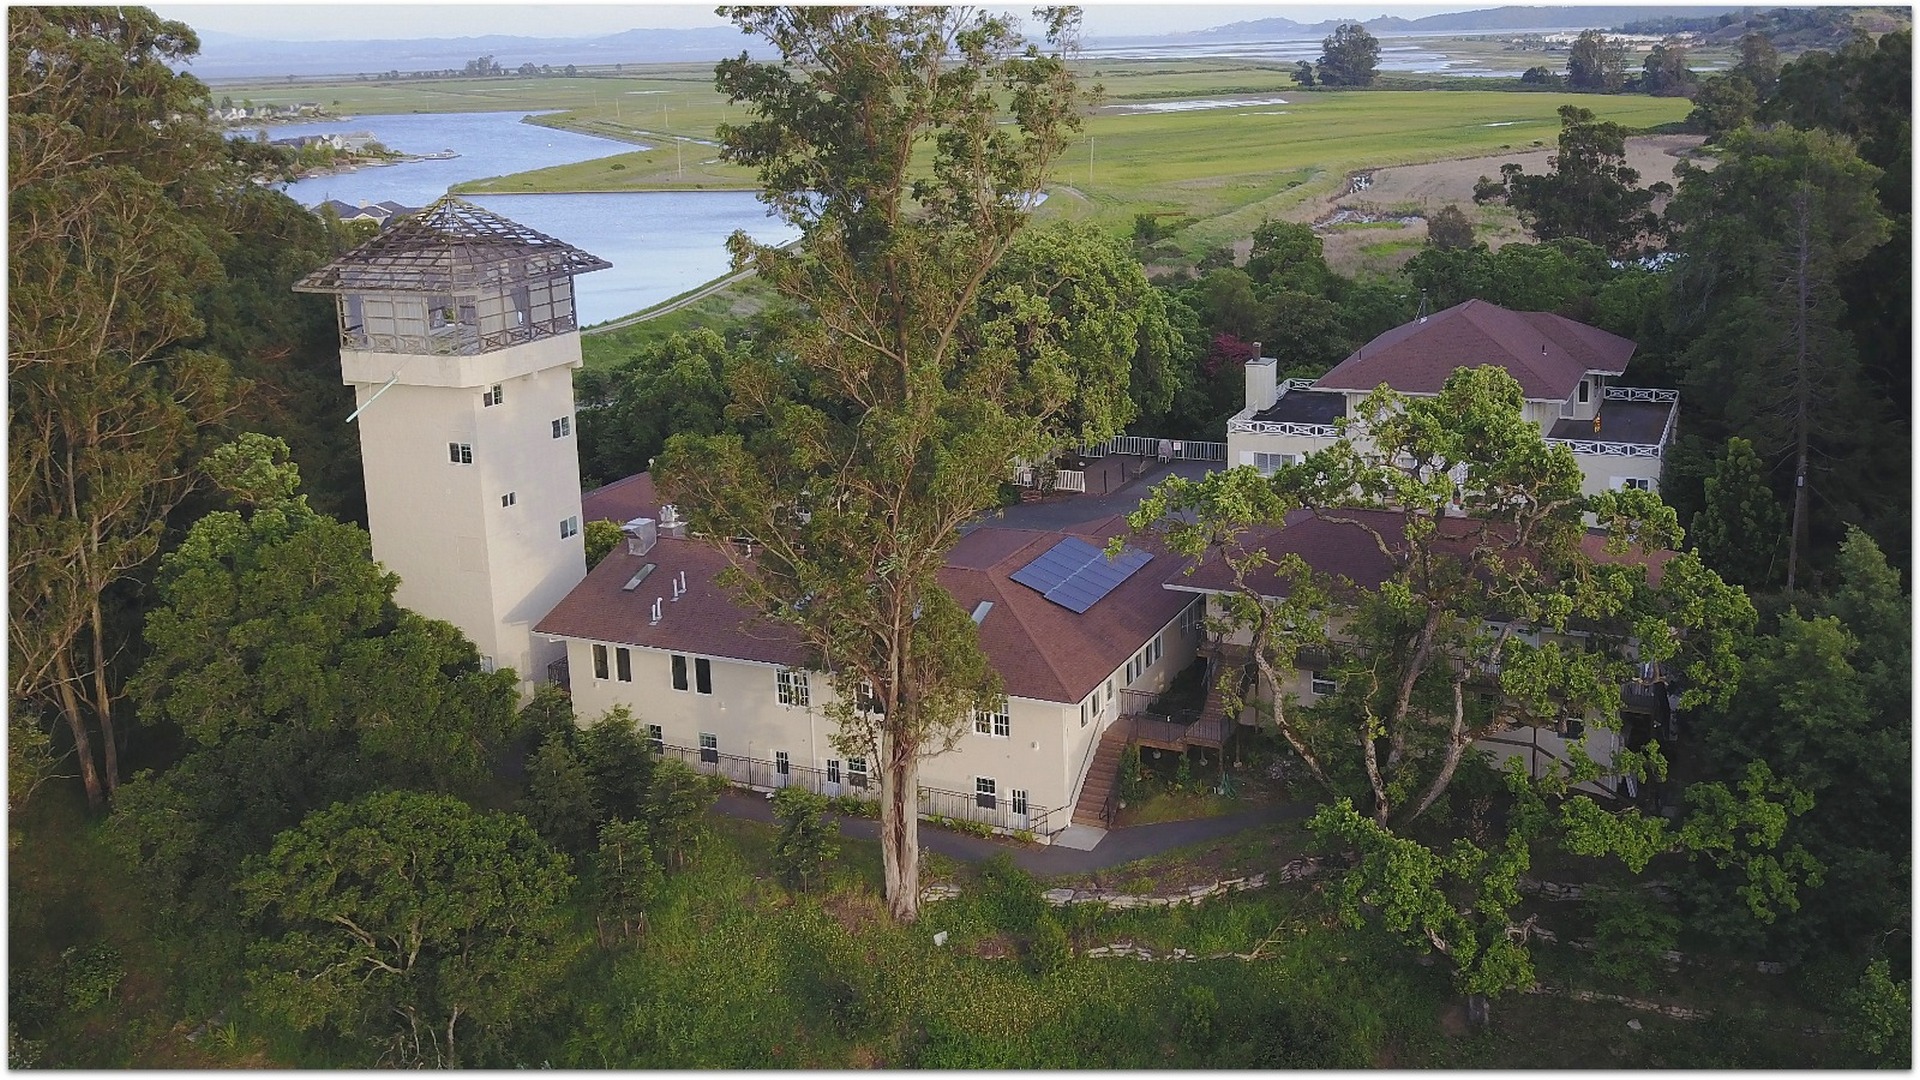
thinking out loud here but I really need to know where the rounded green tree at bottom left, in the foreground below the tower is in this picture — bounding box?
[240,792,574,1068]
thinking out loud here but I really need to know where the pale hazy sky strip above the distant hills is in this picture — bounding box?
[152,0,1500,40]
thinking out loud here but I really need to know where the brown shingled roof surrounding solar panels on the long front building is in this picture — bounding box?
[534,518,1192,703]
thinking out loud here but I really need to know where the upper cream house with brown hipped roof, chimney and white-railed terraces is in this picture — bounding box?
[1227,300,1680,494]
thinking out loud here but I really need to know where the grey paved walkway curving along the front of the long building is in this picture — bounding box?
[714,792,1315,876]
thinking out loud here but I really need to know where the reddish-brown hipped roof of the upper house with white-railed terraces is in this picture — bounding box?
[1313,300,1636,402]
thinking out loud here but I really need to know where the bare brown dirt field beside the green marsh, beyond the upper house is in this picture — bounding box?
[1288,135,1713,275]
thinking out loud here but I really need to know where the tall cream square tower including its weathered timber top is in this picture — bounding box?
[294,196,612,692]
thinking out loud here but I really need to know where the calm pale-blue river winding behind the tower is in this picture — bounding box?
[267,111,795,325]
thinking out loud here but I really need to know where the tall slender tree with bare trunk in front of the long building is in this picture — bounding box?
[659,8,1113,920]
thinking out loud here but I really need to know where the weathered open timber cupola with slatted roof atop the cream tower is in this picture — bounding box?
[294,196,612,356]
